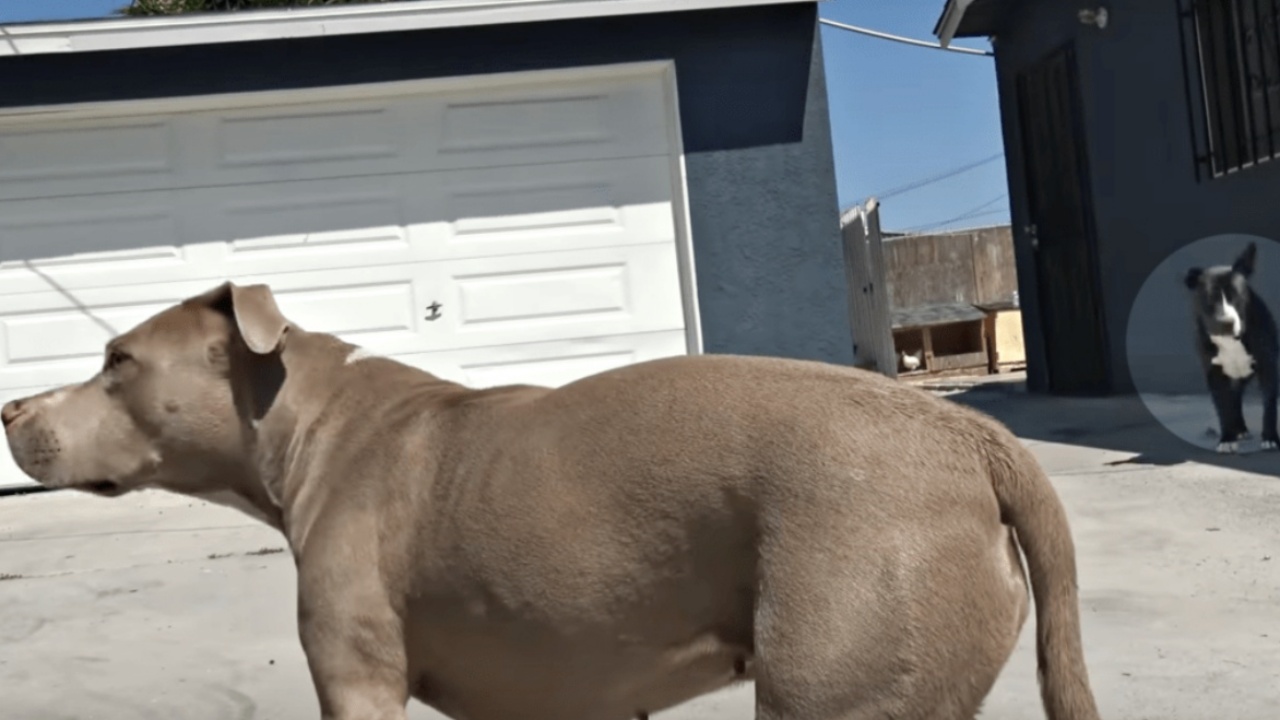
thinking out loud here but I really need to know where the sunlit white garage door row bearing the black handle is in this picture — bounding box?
[0,245,684,387]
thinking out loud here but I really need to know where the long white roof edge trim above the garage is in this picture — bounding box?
[0,0,824,56]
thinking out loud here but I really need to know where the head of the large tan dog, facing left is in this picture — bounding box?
[0,283,288,497]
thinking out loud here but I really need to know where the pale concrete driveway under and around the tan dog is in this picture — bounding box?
[0,379,1280,720]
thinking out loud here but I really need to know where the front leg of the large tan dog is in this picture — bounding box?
[298,562,408,720]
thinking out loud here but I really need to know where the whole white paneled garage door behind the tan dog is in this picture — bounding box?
[0,65,698,486]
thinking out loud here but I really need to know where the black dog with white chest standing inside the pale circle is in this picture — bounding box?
[1184,242,1280,452]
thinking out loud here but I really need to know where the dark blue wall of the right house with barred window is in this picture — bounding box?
[996,0,1280,392]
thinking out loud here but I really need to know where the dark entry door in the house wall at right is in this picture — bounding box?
[1018,45,1110,395]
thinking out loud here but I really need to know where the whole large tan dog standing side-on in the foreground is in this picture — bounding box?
[3,283,1098,720]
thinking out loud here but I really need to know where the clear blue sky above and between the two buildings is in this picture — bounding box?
[0,0,1009,229]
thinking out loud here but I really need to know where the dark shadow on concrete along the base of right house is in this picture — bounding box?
[931,379,1280,477]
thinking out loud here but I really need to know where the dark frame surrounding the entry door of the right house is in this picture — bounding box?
[1012,40,1116,396]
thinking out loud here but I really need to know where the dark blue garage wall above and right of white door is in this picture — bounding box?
[0,4,852,364]
